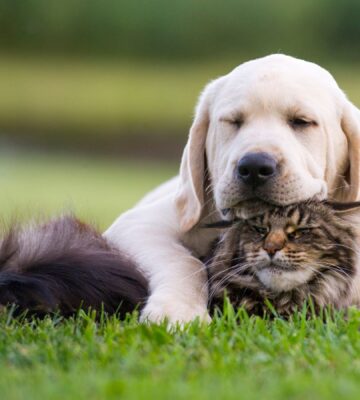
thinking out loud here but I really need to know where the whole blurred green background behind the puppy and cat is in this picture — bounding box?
[0,0,360,228]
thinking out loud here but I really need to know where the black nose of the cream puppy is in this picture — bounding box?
[237,153,277,187]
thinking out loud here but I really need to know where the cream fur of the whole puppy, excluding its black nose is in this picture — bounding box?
[105,55,360,322]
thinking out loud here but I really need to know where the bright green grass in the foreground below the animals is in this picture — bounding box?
[0,309,360,400]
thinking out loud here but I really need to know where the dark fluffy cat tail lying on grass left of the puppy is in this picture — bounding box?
[0,216,148,316]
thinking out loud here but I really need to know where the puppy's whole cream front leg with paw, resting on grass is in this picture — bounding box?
[105,199,210,323]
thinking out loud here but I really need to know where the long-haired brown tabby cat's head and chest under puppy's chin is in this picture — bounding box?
[207,202,360,316]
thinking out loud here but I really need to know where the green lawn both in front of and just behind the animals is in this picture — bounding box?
[0,152,360,400]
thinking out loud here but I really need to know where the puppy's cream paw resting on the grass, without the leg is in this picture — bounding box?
[140,295,211,326]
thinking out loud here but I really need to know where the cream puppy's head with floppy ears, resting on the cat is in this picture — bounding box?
[176,55,360,231]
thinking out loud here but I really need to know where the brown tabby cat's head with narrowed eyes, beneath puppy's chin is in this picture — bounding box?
[217,202,360,292]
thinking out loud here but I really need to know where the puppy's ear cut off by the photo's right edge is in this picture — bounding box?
[341,100,360,201]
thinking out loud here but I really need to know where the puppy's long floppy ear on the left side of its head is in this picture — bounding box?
[175,78,223,232]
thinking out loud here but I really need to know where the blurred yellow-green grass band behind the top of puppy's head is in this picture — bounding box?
[0,54,360,138]
